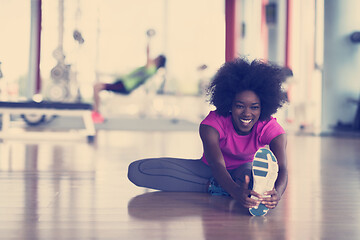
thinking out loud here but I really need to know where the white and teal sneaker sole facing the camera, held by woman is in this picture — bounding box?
[249,148,279,216]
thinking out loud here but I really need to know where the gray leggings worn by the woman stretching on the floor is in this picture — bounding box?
[128,158,252,192]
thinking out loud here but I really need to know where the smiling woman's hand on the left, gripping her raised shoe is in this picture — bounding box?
[230,175,264,208]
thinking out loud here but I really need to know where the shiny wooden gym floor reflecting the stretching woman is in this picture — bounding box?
[0,126,360,240]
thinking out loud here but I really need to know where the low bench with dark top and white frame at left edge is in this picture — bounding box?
[0,101,95,141]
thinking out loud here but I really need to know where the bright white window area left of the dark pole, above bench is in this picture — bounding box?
[0,0,31,101]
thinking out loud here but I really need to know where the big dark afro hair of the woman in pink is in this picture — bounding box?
[208,58,288,121]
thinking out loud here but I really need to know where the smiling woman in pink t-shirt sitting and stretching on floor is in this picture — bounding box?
[128,59,288,216]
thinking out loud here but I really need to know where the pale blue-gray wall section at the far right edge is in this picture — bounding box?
[322,0,360,132]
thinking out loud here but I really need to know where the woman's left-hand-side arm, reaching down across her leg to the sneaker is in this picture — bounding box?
[200,124,262,208]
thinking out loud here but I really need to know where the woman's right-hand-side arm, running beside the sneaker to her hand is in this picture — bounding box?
[262,134,288,208]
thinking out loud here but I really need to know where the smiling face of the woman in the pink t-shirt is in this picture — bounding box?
[231,90,261,135]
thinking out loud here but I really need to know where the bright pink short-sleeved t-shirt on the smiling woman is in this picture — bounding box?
[201,111,285,169]
